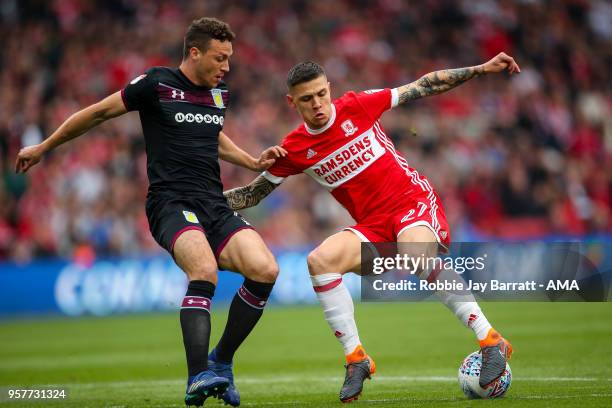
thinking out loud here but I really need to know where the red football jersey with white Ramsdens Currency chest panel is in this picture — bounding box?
[263,89,440,230]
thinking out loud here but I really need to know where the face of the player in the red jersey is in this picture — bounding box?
[287,75,331,129]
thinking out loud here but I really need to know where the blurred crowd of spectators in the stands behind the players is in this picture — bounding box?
[0,0,612,262]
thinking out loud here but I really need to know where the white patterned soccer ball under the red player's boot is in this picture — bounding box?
[458,351,512,399]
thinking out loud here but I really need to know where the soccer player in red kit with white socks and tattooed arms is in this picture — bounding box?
[225,53,520,402]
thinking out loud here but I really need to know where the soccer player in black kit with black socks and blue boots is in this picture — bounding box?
[15,18,286,406]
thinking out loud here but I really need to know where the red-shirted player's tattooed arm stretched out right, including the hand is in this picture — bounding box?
[397,52,521,103]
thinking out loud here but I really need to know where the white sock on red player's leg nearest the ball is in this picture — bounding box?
[419,270,491,341]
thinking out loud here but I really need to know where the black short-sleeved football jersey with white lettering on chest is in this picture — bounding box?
[121,67,229,199]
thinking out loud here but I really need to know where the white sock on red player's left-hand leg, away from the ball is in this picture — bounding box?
[310,273,361,355]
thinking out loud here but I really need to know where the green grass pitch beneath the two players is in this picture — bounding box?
[0,302,612,408]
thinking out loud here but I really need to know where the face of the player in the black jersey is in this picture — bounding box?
[193,39,233,88]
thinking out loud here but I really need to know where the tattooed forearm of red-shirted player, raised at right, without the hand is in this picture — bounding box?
[398,66,484,103]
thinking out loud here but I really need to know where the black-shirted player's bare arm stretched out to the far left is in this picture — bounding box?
[15,92,127,173]
